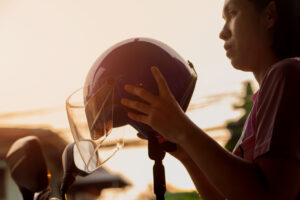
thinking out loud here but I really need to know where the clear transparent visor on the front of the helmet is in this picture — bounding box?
[66,80,124,173]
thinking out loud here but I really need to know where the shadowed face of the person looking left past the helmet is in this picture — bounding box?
[220,0,272,72]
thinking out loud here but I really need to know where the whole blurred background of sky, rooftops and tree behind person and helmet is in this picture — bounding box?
[0,0,257,200]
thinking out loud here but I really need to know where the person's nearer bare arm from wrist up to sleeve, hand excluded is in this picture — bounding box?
[177,121,300,200]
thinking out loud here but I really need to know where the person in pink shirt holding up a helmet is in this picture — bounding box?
[122,0,300,200]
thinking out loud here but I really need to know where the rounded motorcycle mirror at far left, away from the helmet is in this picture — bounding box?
[6,136,49,199]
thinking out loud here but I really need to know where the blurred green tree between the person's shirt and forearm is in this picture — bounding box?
[225,81,253,151]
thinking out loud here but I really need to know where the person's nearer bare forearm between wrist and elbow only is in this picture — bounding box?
[180,124,267,199]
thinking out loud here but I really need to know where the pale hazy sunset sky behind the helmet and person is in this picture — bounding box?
[0,0,253,198]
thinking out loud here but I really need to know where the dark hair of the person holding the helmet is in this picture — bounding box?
[249,0,300,59]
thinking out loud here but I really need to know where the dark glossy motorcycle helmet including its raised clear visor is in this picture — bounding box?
[67,38,197,171]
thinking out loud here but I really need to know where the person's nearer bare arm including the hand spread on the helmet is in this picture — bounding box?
[122,67,300,200]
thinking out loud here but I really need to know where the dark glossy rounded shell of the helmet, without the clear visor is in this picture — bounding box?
[84,38,197,137]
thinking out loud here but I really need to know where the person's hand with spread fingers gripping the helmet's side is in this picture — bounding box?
[121,67,190,143]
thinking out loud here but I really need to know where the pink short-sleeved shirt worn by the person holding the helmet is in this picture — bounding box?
[234,58,300,161]
